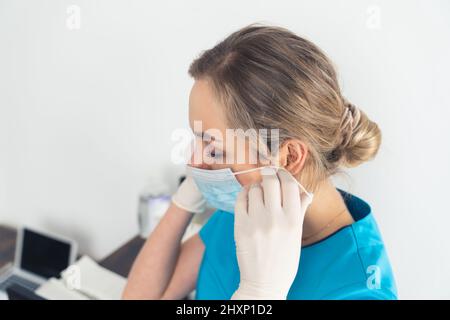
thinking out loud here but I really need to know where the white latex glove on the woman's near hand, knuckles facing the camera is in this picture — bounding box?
[231,170,312,300]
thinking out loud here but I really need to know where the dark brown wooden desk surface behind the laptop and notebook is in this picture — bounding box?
[0,225,145,277]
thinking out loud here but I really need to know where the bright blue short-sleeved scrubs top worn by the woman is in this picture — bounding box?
[196,189,397,300]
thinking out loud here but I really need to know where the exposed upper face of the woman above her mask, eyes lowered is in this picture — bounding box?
[189,79,261,186]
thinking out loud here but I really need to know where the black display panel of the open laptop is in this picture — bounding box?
[20,228,71,278]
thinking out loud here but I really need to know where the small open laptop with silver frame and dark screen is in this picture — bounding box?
[0,227,77,291]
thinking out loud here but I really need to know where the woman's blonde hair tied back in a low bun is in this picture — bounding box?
[189,24,381,189]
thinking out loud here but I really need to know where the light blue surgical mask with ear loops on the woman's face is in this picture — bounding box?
[187,166,312,213]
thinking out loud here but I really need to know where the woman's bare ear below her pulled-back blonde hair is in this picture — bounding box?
[279,139,308,176]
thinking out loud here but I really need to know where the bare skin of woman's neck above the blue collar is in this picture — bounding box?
[302,179,354,246]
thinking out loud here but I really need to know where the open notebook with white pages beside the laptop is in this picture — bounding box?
[35,256,126,300]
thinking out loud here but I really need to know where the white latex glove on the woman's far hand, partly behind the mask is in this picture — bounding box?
[172,176,206,213]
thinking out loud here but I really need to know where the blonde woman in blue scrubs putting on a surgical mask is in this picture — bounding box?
[123,25,397,299]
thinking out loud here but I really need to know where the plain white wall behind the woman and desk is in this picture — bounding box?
[0,0,450,298]
